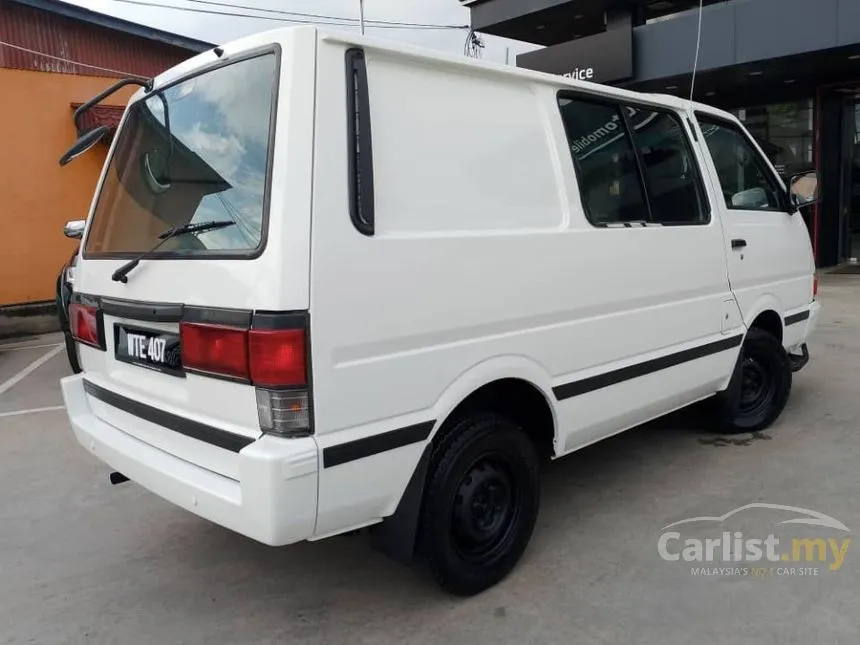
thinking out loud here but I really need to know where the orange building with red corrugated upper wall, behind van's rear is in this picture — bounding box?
[0,0,211,307]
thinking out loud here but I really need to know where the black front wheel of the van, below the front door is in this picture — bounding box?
[717,328,792,434]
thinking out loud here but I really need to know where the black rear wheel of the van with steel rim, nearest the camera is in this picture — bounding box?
[419,413,540,596]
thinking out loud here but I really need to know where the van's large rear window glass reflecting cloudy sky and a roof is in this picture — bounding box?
[85,53,276,257]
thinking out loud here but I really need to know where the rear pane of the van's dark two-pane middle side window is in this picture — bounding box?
[559,97,648,226]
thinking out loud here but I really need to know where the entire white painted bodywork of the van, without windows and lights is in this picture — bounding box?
[63,28,818,544]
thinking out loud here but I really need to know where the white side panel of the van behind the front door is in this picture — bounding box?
[311,41,743,528]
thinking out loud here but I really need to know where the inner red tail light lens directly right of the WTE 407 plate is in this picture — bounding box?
[179,323,250,380]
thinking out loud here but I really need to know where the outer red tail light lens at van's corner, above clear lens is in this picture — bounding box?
[248,329,308,387]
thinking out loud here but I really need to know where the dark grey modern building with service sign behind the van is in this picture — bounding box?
[461,0,860,266]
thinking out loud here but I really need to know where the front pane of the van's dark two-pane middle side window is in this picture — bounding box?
[625,107,709,224]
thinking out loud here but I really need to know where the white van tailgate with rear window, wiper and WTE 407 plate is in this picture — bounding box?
[73,31,315,479]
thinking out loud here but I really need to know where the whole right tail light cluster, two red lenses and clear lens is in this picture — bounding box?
[179,318,313,437]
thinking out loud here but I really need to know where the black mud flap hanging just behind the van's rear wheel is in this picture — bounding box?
[371,443,432,565]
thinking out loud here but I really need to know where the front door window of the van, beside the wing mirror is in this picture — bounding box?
[698,115,782,210]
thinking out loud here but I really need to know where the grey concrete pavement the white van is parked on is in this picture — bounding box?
[0,276,860,645]
